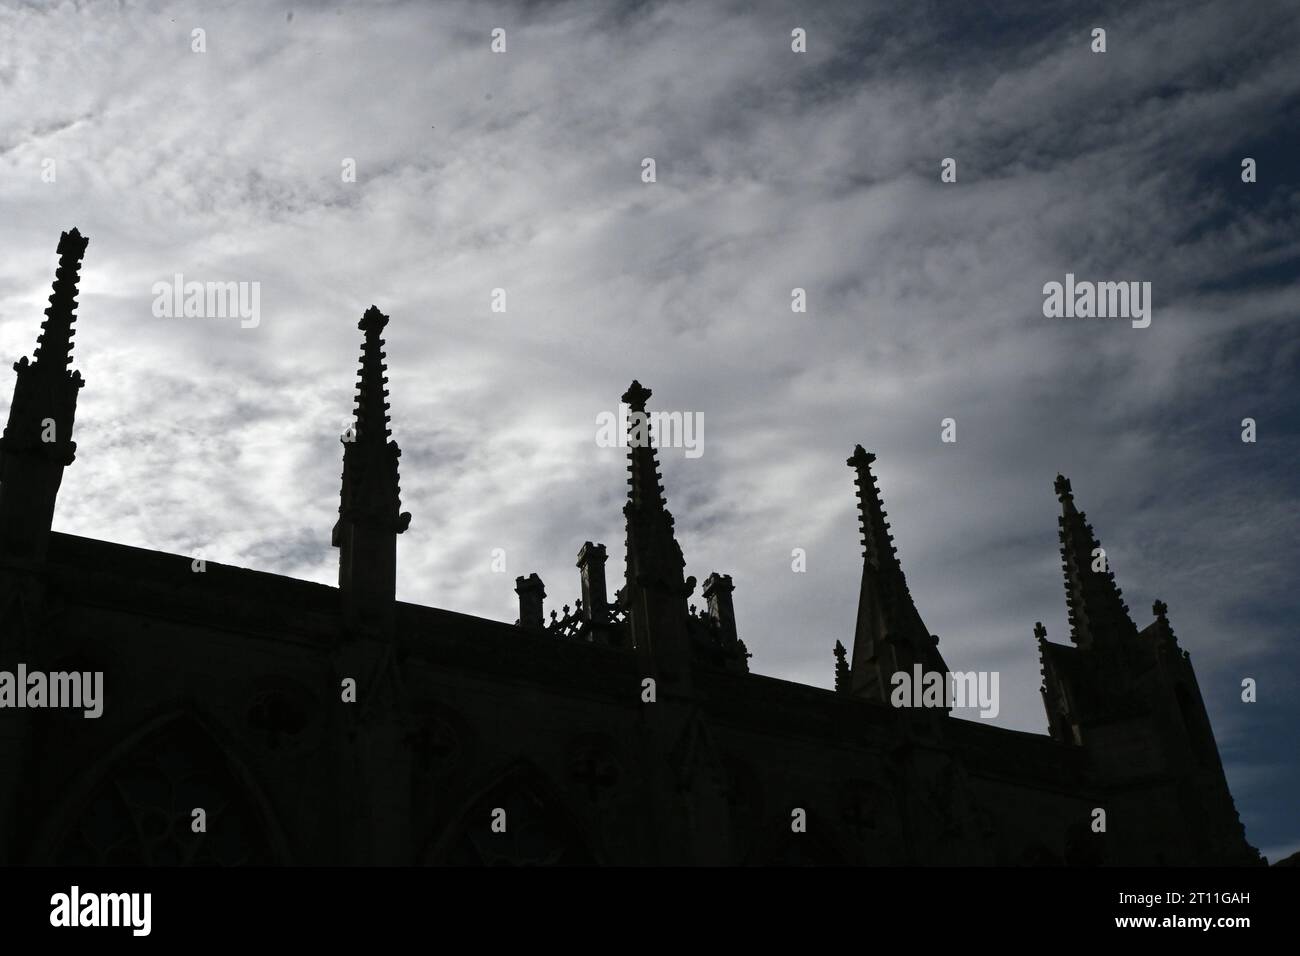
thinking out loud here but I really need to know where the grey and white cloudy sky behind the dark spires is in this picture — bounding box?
[0,0,1300,858]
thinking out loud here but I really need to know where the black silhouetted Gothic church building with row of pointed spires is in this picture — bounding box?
[0,229,1262,865]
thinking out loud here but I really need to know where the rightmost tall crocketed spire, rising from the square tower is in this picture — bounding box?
[1056,475,1138,648]
